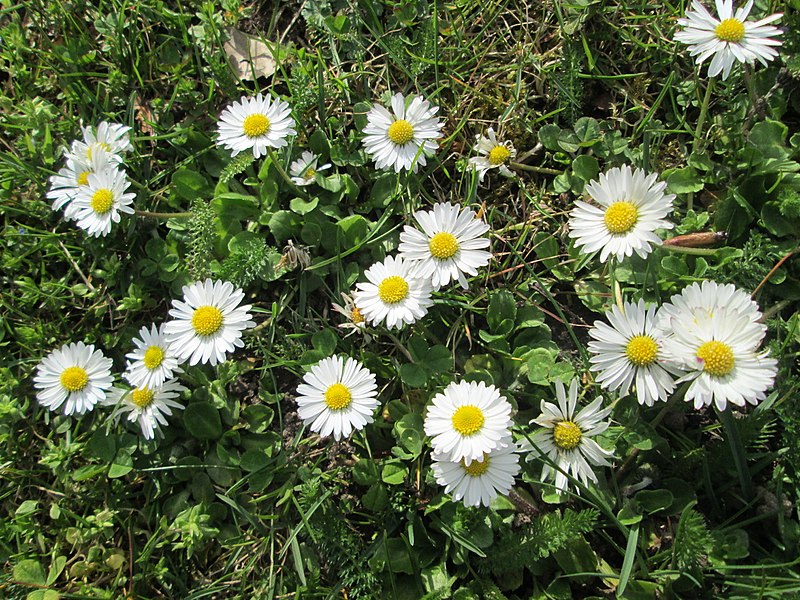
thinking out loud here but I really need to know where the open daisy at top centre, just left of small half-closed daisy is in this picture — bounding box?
[363,93,444,173]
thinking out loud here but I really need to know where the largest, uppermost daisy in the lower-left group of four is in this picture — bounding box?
[163,279,255,366]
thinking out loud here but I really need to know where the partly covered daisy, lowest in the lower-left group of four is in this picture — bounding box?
[104,379,186,440]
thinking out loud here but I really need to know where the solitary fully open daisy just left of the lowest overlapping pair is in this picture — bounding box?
[297,356,378,442]
